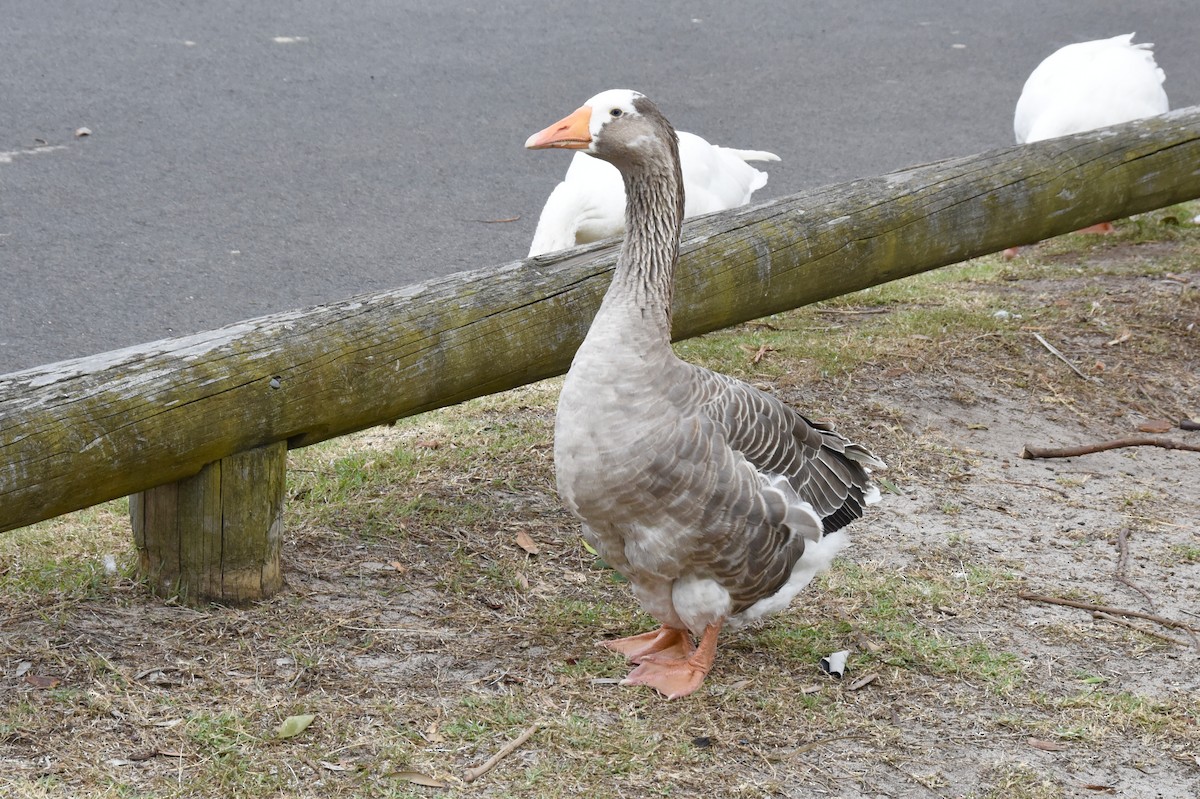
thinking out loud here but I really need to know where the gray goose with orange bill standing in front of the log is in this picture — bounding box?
[526,90,883,698]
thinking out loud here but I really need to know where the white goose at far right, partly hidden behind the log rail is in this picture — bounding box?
[1004,34,1170,251]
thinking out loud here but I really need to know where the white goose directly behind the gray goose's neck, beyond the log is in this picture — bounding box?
[529,131,779,257]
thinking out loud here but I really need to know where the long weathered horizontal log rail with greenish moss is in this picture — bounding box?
[0,107,1200,593]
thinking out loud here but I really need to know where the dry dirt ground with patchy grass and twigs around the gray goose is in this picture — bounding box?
[0,233,1200,799]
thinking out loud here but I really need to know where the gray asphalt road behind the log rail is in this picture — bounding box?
[0,0,1200,373]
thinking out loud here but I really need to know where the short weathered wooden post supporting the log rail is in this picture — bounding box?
[130,441,288,605]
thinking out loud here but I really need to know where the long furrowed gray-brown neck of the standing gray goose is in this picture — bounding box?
[606,147,684,342]
